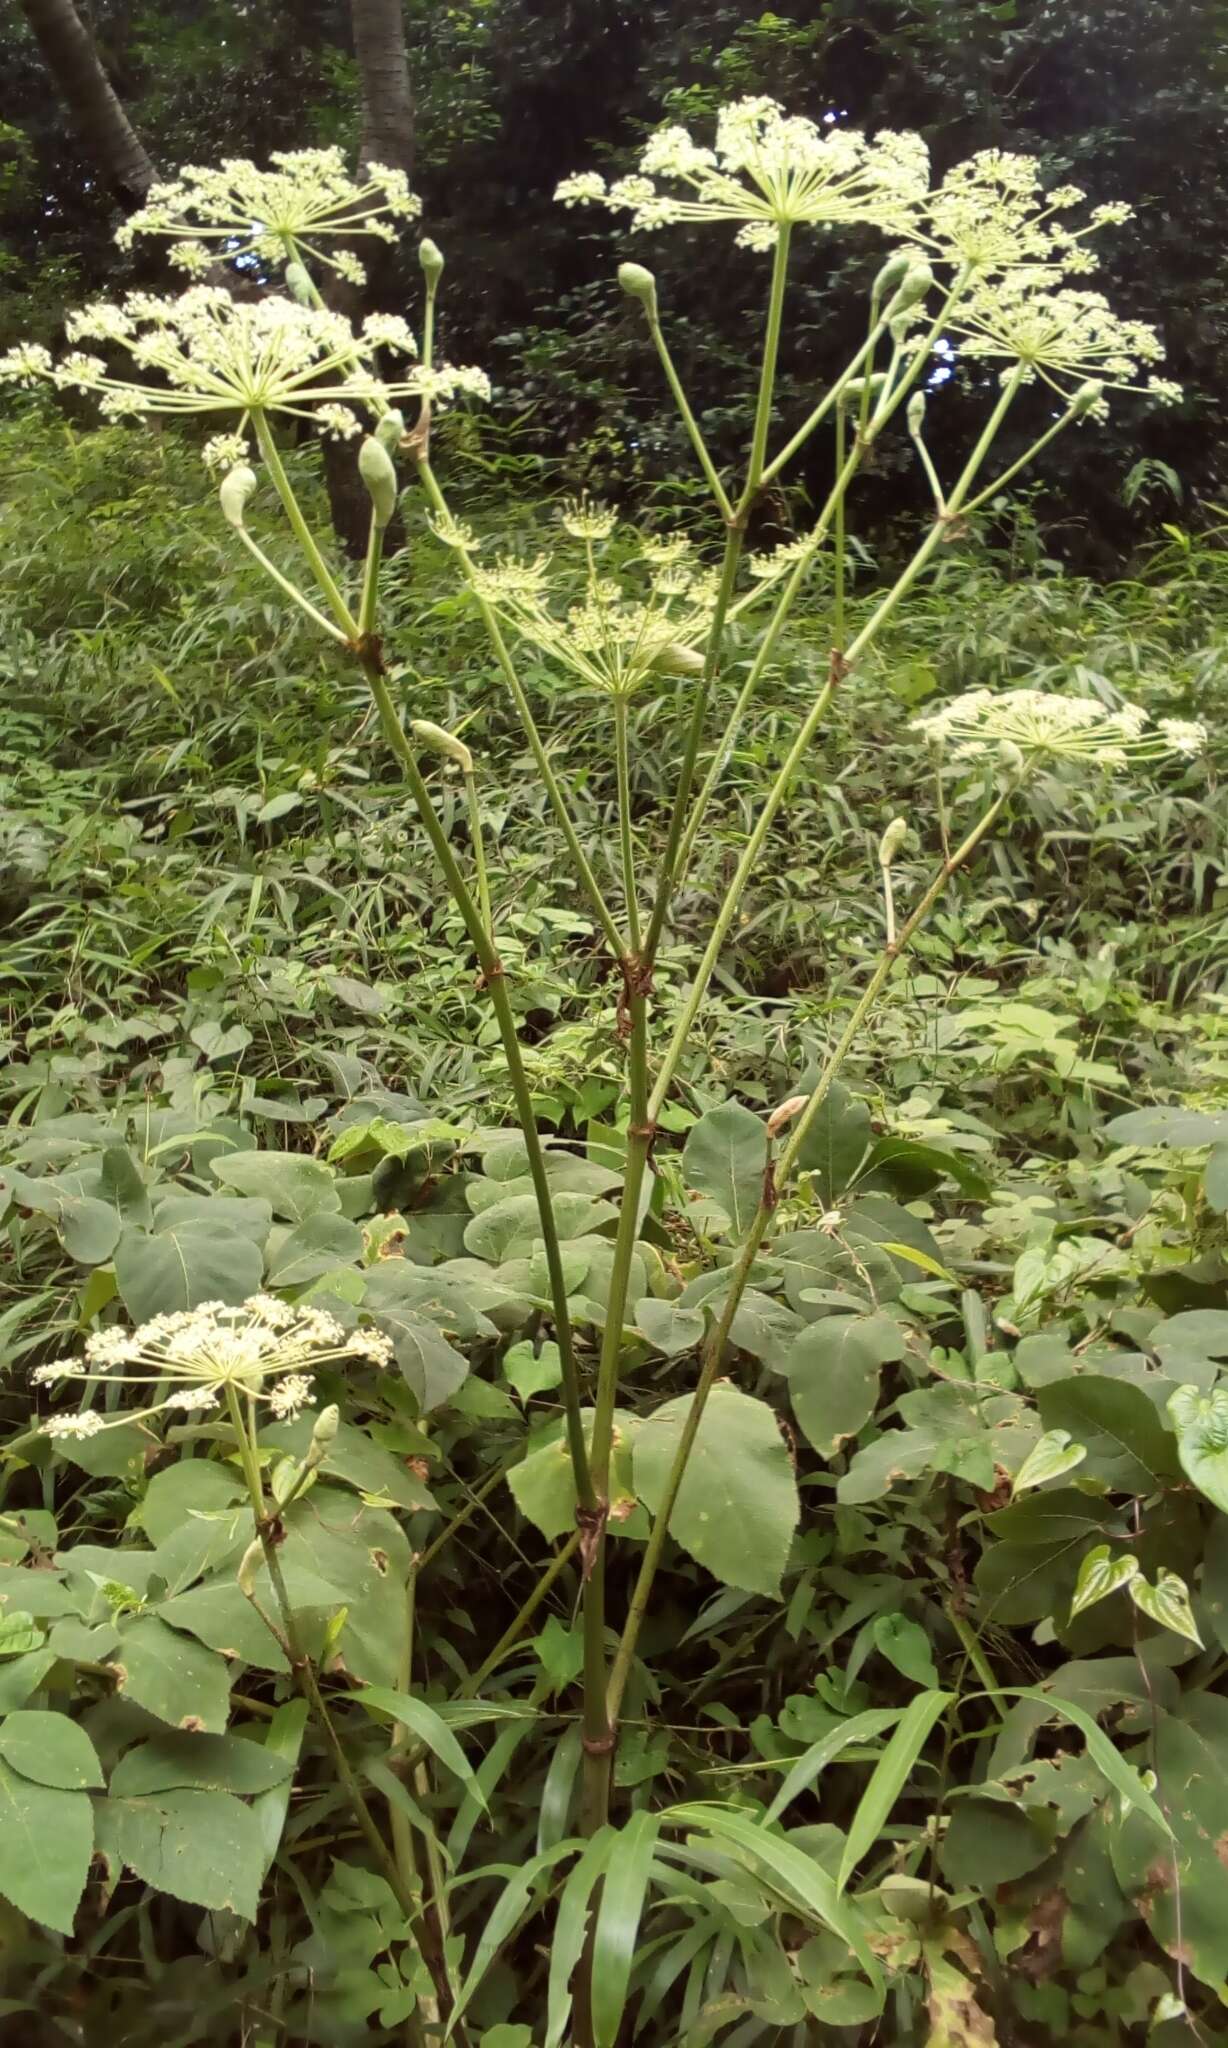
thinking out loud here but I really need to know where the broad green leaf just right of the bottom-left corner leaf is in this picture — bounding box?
[98,1786,264,1921]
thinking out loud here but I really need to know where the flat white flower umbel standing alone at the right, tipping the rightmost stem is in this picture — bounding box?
[913,690,1208,768]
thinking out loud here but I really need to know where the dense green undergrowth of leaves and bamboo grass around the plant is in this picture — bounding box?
[0,410,1228,2048]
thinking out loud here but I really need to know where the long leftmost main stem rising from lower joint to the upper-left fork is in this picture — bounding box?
[360,651,596,1509]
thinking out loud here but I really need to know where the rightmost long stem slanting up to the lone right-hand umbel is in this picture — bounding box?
[606,791,1009,1722]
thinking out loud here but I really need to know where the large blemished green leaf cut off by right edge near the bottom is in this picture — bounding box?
[1109,1692,1228,1991]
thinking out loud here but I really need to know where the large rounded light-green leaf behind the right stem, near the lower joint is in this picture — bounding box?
[632,1384,798,1597]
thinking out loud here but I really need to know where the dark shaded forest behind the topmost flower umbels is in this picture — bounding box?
[0,0,1228,571]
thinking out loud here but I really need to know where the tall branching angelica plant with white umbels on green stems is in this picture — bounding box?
[0,100,1201,1966]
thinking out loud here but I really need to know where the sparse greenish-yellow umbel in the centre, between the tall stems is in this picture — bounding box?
[469,500,716,696]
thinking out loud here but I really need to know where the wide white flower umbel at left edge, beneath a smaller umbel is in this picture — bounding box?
[0,285,491,448]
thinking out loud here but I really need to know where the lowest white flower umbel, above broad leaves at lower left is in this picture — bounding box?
[31,1294,393,1438]
